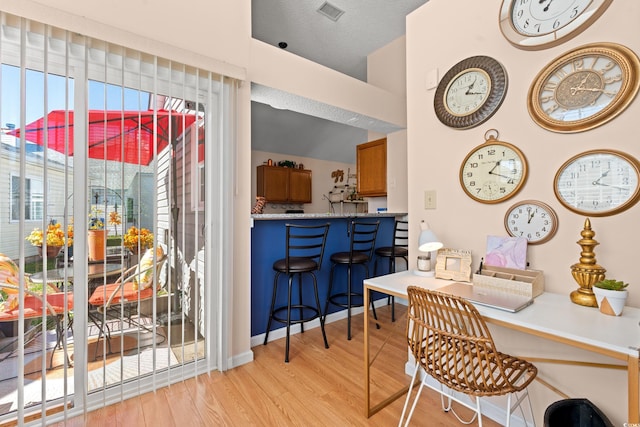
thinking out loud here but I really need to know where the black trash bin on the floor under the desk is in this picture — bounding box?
[544,399,614,427]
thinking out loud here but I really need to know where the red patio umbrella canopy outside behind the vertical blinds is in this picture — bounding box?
[10,110,197,165]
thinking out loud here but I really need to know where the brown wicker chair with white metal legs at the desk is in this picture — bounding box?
[399,286,538,426]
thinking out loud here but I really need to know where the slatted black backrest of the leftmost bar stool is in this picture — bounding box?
[285,223,330,271]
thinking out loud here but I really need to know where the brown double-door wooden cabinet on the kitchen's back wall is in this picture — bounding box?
[257,165,311,203]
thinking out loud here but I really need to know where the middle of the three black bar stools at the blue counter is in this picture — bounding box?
[324,221,380,340]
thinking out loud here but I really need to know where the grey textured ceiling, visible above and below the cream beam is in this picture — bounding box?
[251,0,427,163]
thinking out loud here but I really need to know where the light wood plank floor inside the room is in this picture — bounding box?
[52,306,498,427]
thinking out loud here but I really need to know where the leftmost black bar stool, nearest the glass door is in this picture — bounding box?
[264,223,330,363]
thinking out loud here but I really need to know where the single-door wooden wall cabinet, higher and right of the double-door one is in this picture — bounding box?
[356,138,387,197]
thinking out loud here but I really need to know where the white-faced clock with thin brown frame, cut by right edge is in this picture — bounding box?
[553,149,640,216]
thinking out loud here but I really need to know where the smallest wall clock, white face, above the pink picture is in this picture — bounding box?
[504,200,558,245]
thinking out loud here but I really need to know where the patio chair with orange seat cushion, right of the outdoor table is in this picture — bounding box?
[89,246,167,359]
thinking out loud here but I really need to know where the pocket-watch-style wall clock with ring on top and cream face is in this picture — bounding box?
[460,129,527,203]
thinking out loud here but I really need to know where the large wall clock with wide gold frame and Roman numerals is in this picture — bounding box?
[527,43,640,133]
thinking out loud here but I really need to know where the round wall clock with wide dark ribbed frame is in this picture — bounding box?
[433,56,507,129]
